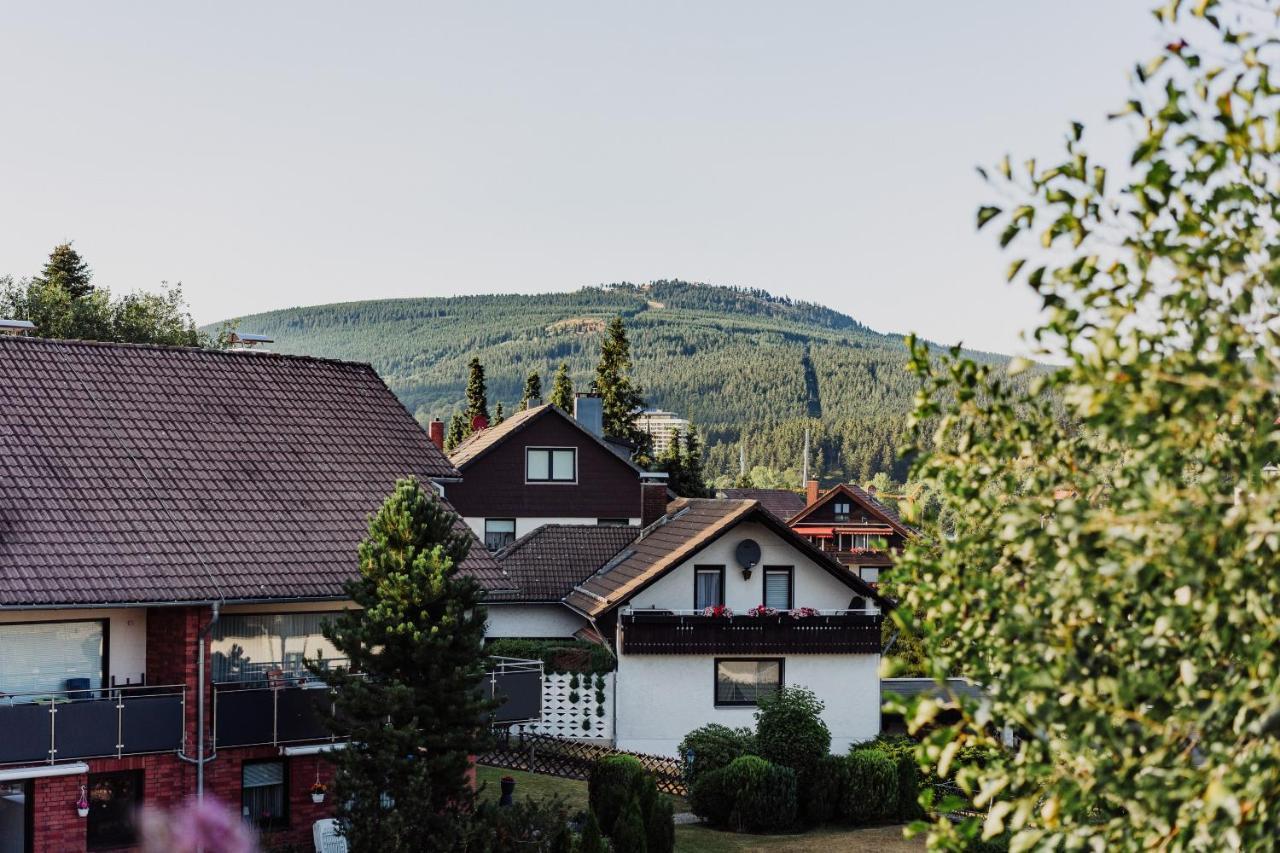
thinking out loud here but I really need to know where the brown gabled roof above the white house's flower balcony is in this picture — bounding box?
[564,498,883,616]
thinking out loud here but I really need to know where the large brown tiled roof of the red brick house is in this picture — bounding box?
[0,337,504,606]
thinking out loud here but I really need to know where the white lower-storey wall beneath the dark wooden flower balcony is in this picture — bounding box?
[616,654,881,756]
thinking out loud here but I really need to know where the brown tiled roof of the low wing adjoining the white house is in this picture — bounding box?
[489,524,640,602]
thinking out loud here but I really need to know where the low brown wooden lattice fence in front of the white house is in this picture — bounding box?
[476,730,687,797]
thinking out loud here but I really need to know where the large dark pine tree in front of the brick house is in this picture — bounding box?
[312,479,488,853]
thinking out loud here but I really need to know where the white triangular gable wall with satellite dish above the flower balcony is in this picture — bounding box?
[631,523,855,613]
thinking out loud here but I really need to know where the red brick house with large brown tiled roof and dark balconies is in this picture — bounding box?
[0,337,529,853]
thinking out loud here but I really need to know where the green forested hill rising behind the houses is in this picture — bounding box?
[215,280,1003,484]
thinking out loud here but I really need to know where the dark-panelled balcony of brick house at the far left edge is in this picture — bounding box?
[0,685,186,763]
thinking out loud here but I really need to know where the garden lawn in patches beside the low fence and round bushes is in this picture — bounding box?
[476,765,924,853]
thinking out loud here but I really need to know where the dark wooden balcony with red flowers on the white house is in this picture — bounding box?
[621,610,881,654]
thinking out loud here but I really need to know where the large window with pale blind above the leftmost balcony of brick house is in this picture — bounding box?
[0,619,106,702]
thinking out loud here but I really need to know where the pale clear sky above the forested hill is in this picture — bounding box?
[0,0,1161,353]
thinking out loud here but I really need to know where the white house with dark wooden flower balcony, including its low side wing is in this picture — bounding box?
[489,500,882,756]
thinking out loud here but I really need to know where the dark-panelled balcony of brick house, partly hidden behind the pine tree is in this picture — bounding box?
[214,658,543,747]
